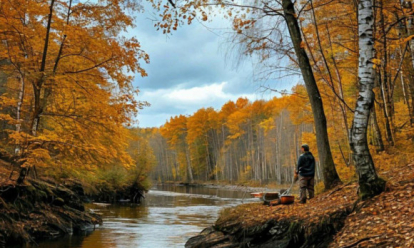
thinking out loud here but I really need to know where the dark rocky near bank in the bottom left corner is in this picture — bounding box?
[0,178,102,247]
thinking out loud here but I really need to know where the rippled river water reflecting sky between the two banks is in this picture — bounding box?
[38,186,257,248]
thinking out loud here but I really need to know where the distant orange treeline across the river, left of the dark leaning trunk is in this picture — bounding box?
[141,85,347,184]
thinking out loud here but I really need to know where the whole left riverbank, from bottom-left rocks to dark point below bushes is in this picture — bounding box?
[0,155,152,247]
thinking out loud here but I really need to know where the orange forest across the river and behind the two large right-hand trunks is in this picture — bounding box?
[141,1,414,195]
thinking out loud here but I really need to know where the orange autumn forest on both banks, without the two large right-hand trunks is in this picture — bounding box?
[0,1,414,194]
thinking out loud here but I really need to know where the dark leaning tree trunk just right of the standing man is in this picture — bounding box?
[282,0,340,189]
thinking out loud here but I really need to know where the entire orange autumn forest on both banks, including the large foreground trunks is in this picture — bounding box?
[0,0,414,247]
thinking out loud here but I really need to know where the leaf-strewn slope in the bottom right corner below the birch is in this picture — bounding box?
[332,164,414,247]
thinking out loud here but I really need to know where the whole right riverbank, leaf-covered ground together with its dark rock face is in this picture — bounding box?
[185,164,414,248]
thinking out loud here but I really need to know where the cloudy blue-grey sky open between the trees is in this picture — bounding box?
[131,6,298,127]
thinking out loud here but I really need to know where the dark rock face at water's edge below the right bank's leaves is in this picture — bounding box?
[185,208,347,248]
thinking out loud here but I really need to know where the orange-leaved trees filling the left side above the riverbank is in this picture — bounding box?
[0,0,149,189]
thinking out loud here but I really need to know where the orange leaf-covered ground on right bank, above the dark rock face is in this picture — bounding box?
[216,164,414,248]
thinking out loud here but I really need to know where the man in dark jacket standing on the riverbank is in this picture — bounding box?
[295,144,315,203]
